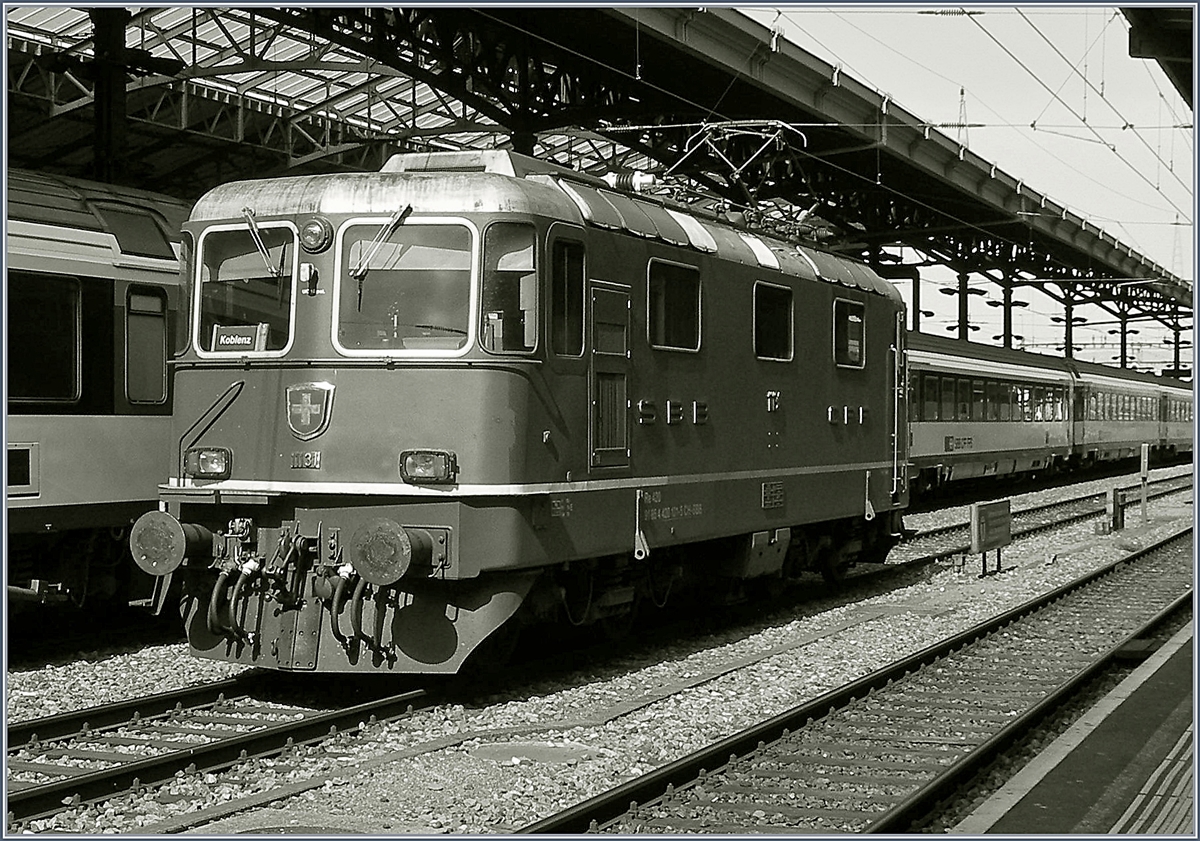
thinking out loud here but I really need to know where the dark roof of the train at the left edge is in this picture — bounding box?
[6,169,188,237]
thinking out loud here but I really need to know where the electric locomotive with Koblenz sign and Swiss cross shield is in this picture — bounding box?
[130,151,907,673]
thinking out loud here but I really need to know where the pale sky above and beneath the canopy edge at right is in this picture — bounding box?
[739,4,1195,368]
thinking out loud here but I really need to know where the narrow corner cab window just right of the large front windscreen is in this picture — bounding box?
[480,222,538,354]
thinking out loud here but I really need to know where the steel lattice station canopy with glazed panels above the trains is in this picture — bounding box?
[7,6,1192,331]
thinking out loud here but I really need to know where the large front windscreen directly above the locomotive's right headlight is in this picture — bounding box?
[337,220,472,352]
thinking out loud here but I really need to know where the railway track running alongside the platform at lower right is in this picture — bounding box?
[521,528,1193,834]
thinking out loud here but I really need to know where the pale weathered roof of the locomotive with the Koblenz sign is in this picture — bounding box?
[191,150,901,302]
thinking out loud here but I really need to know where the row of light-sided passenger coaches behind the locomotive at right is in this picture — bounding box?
[908,323,1193,493]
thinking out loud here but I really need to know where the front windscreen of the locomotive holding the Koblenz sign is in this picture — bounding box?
[199,224,295,353]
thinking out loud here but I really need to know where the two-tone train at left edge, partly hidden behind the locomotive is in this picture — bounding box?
[5,169,188,605]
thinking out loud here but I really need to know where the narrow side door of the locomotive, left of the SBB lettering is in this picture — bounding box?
[588,281,629,470]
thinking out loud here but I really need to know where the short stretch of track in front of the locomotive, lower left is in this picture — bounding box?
[7,675,425,830]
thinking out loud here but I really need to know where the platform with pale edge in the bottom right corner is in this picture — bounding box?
[949,625,1196,837]
